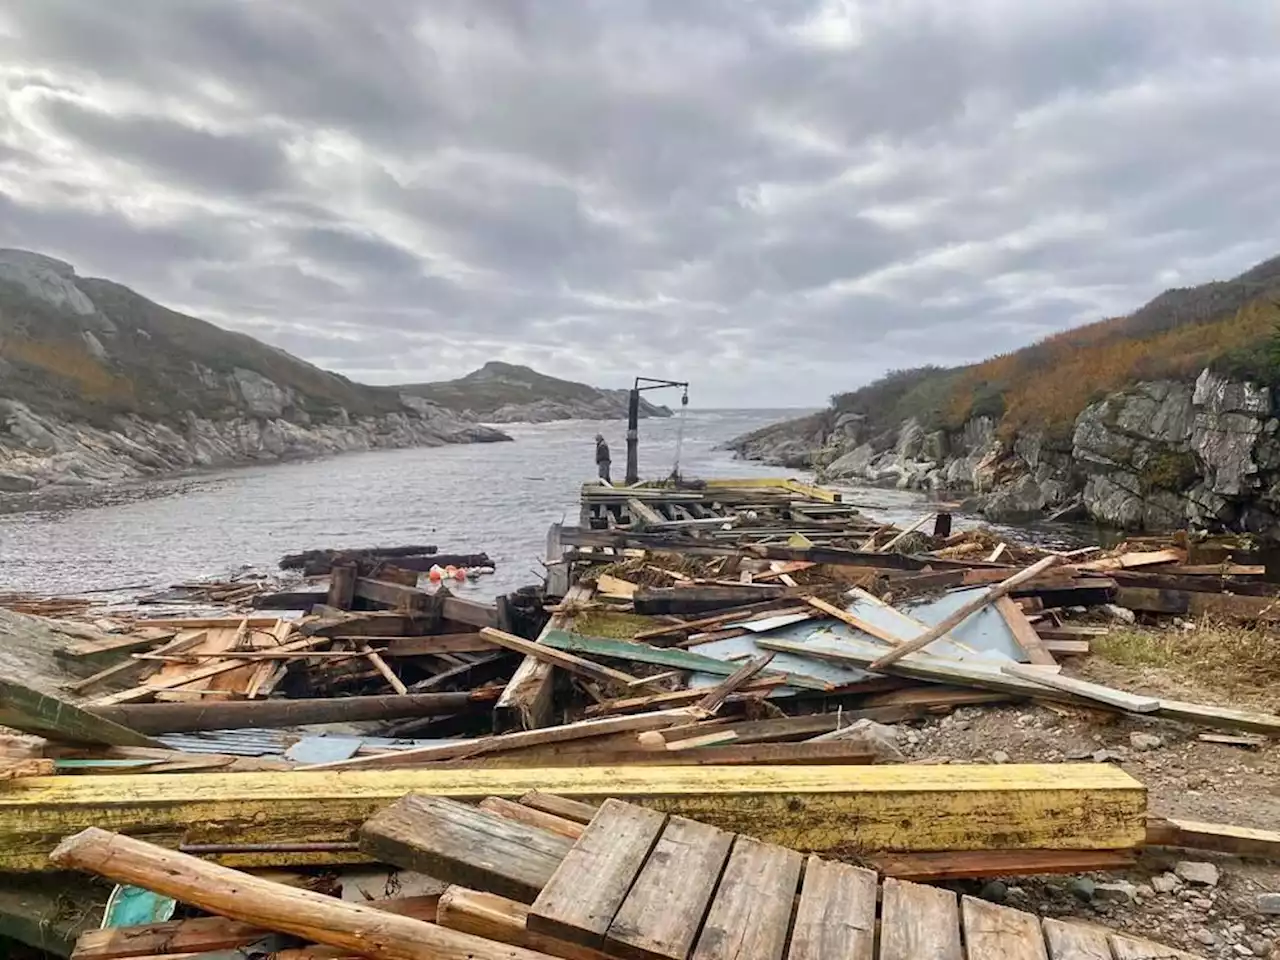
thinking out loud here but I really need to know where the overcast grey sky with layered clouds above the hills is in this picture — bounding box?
[0,0,1280,406]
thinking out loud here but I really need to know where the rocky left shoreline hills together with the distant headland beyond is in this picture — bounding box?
[0,250,671,494]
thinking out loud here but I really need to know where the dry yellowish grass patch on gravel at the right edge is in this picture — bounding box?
[1092,621,1280,690]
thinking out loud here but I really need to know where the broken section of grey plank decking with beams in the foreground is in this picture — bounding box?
[365,794,1192,960]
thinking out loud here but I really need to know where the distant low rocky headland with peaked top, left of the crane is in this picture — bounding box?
[398,361,671,424]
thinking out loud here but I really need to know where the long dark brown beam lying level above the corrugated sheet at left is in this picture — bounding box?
[90,692,492,733]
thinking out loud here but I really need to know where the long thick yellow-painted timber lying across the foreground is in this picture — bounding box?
[0,764,1146,870]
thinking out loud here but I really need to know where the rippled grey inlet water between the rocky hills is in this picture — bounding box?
[0,411,942,596]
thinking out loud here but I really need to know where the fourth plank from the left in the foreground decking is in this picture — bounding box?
[787,856,876,960]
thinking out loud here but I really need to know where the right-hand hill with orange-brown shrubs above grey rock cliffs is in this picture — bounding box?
[731,257,1280,536]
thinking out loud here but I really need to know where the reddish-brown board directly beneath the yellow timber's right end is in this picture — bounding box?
[865,855,1149,883]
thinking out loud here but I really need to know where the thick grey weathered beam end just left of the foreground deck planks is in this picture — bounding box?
[360,794,573,904]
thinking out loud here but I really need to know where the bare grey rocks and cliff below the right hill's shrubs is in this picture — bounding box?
[728,369,1280,535]
